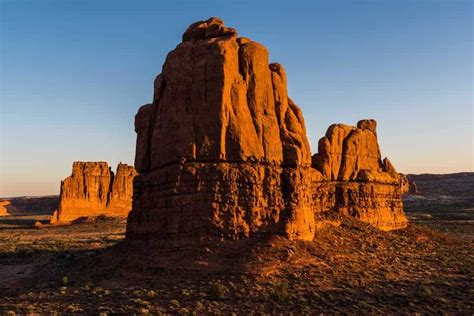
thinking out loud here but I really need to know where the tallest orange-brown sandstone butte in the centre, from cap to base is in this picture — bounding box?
[127,18,319,244]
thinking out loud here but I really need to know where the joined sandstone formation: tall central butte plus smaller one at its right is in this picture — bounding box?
[127,18,407,245]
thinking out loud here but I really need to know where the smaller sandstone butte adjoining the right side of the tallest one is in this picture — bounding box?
[312,120,408,230]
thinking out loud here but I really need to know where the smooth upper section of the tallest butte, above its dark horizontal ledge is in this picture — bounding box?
[135,18,311,172]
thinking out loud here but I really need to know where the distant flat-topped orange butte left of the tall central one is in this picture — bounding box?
[51,161,137,224]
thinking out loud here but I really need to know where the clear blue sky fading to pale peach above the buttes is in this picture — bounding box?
[0,0,473,196]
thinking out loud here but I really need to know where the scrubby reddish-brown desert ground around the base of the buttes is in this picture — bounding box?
[0,173,474,315]
